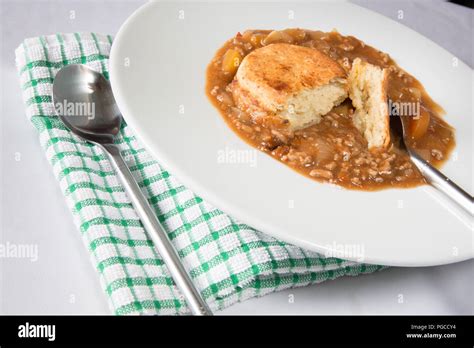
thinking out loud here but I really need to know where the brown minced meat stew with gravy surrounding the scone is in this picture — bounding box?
[206,29,455,190]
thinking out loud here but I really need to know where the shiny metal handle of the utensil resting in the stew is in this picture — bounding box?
[410,151,473,216]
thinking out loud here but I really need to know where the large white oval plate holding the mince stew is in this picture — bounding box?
[110,1,473,266]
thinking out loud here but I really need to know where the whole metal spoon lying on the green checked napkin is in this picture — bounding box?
[53,65,212,315]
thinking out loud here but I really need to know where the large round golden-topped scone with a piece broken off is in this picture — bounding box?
[232,44,347,131]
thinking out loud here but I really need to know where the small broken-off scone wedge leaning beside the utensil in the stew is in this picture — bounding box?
[347,58,390,149]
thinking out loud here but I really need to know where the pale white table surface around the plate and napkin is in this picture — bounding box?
[0,0,474,314]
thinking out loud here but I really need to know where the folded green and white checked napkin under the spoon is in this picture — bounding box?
[16,33,382,314]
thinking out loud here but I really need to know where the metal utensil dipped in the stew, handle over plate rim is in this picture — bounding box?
[390,116,473,216]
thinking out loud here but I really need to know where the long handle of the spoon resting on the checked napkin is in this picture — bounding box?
[98,144,212,315]
